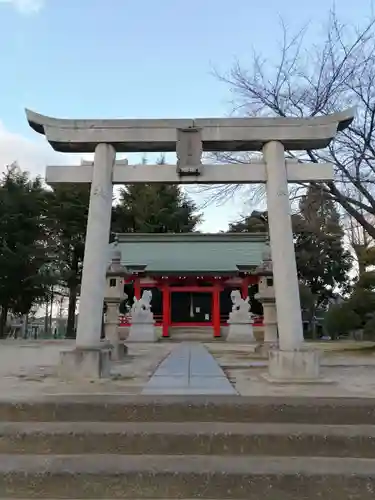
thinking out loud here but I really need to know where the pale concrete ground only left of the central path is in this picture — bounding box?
[0,340,176,397]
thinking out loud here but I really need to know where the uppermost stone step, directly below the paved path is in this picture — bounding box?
[0,394,375,425]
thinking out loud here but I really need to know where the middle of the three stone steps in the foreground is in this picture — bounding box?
[0,422,375,458]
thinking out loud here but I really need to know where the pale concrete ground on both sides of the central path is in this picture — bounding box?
[0,340,375,398]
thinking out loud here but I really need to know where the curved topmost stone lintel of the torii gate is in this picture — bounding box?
[26,108,355,153]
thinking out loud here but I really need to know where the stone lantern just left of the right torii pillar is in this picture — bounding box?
[255,245,278,347]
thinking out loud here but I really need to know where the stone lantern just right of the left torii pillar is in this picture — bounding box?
[104,244,127,361]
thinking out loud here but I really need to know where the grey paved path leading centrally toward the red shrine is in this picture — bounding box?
[142,343,238,395]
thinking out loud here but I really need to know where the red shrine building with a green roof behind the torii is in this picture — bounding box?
[110,233,267,338]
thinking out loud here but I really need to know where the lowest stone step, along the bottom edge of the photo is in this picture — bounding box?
[0,455,375,500]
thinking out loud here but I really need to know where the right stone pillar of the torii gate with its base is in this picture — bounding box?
[263,141,323,383]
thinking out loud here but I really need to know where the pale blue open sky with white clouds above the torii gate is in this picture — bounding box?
[0,0,372,231]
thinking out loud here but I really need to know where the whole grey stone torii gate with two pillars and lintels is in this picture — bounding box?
[26,109,354,380]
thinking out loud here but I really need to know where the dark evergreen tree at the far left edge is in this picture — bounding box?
[0,164,54,337]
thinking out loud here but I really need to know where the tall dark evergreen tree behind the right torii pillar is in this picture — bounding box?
[229,194,352,334]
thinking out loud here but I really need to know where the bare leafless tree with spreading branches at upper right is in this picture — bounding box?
[210,12,375,238]
